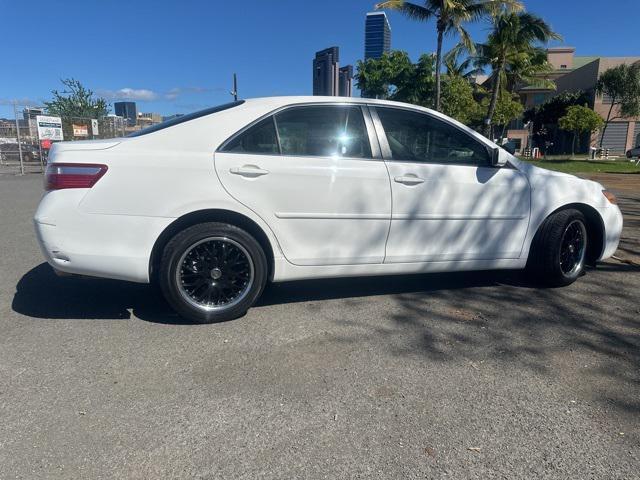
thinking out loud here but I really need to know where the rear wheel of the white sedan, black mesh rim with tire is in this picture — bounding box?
[159,222,267,323]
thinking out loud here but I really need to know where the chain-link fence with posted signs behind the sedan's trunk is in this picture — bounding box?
[0,105,127,174]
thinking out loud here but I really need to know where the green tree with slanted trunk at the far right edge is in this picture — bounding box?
[596,63,640,148]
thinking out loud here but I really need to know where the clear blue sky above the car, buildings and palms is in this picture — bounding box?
[0,0,640,117]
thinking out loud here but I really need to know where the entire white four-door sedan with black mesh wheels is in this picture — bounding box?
[35,97,622,322]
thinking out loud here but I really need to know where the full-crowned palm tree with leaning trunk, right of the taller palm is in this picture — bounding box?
[475,12,562,135]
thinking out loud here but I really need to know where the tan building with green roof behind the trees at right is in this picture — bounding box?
[507,47,640,154]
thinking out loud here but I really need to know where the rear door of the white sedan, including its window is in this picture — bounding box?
[215,104,391,265]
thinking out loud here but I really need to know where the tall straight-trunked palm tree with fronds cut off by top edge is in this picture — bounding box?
[375,0,523,110]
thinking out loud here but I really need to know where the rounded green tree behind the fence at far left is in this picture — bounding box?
[44,78,109,118]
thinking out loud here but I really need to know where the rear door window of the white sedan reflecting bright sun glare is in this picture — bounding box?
[275,105,371,158]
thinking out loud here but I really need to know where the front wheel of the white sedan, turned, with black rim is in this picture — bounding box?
[527,209,587,287]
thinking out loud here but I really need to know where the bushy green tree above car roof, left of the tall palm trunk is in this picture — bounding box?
[355,50,434,106]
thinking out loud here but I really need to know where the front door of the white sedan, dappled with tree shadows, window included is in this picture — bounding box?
[371,106,530,263]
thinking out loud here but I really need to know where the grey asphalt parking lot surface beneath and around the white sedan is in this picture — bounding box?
[0,174,640,479]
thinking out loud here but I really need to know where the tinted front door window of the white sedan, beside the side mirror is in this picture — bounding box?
[376,107,490,165]
